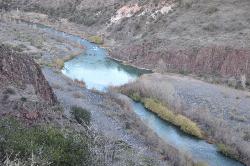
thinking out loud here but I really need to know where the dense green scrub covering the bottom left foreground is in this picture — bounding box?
[0,118,91,166]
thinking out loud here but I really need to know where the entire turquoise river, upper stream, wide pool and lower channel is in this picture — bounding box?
[24,21,242,166]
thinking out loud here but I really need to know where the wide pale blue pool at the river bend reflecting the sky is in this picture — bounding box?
[62,40,148,91]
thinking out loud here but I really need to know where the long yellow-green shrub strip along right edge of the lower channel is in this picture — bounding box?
[142,98,203,138]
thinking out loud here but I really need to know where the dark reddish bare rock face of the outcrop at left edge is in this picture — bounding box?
[0,45,57,105]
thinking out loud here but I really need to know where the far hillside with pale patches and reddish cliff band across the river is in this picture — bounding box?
[1,0,250,88]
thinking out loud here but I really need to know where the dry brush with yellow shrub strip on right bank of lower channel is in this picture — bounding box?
[119,74,249,163]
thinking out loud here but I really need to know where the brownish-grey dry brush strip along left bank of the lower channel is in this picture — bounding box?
[107,92,203,166]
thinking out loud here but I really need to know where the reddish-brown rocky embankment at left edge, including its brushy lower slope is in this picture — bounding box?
[0,45,57,120]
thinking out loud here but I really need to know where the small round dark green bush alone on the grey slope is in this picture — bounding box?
[71,106,91,125]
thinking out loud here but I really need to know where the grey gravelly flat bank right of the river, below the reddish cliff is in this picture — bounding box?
[121,73,250,165]
